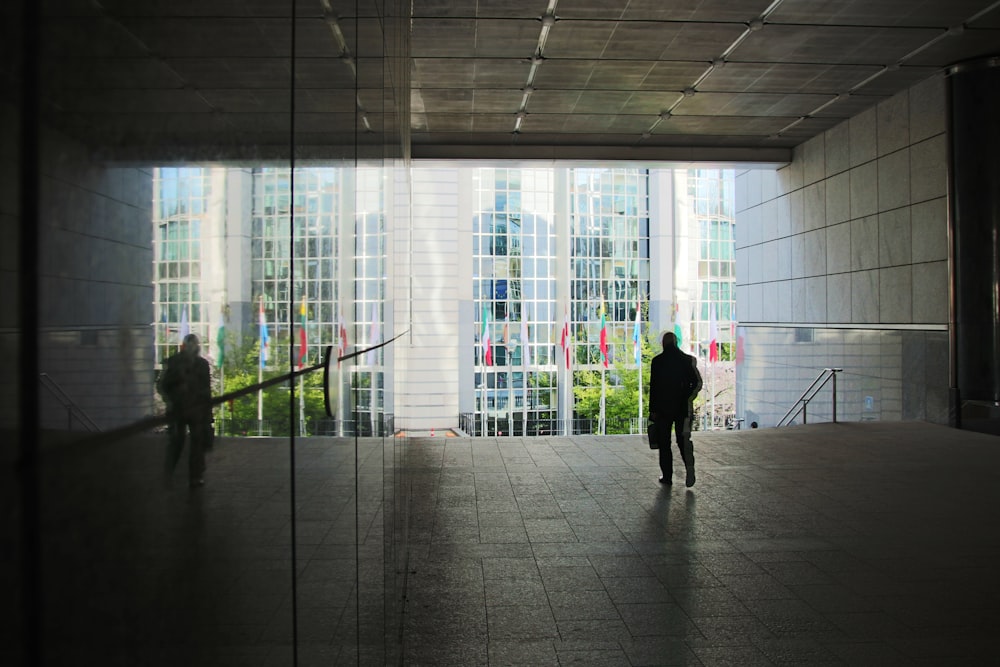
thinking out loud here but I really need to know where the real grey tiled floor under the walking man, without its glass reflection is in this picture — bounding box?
[396,423,1000,667]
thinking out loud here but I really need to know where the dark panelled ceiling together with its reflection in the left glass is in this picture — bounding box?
[2,0,1000,162]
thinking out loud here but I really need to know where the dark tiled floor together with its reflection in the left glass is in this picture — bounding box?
[11,423,1000,667]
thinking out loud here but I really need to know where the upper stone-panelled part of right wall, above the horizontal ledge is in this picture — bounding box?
[736,77,948,326]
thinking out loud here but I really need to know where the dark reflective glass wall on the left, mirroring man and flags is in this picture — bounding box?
[9,0,409,665]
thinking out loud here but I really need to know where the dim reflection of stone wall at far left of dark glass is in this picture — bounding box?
[0,108,153,429]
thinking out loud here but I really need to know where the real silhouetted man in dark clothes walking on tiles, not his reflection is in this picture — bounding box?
[649,333,701,487]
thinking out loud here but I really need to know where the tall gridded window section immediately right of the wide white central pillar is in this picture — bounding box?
[472,168,558,435]
